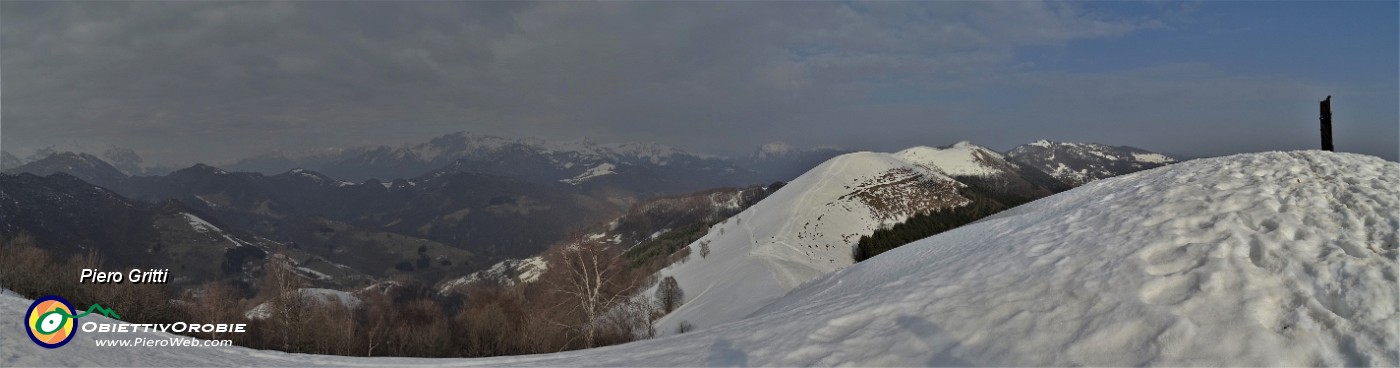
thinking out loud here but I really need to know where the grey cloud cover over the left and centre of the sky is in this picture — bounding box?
[10,1,1355,164]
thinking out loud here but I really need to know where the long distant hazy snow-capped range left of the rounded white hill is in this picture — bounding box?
[228,133,766,194]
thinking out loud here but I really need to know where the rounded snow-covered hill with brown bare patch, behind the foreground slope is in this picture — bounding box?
[658,153,967,334]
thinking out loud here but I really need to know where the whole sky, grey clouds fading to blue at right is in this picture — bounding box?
[0,1,1400,164]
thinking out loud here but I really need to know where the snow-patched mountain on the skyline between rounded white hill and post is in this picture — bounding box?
[1007,140,1176,186]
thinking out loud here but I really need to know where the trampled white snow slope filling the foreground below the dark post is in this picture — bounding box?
[0,151,1400,367]
